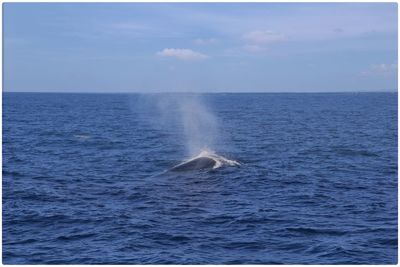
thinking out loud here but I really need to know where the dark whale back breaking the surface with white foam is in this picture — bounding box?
[170,150,240,172]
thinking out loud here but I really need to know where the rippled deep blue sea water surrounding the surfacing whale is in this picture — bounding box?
[2,93,398,264]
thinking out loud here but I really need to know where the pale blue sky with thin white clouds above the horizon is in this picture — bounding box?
[3,3,398,93]
